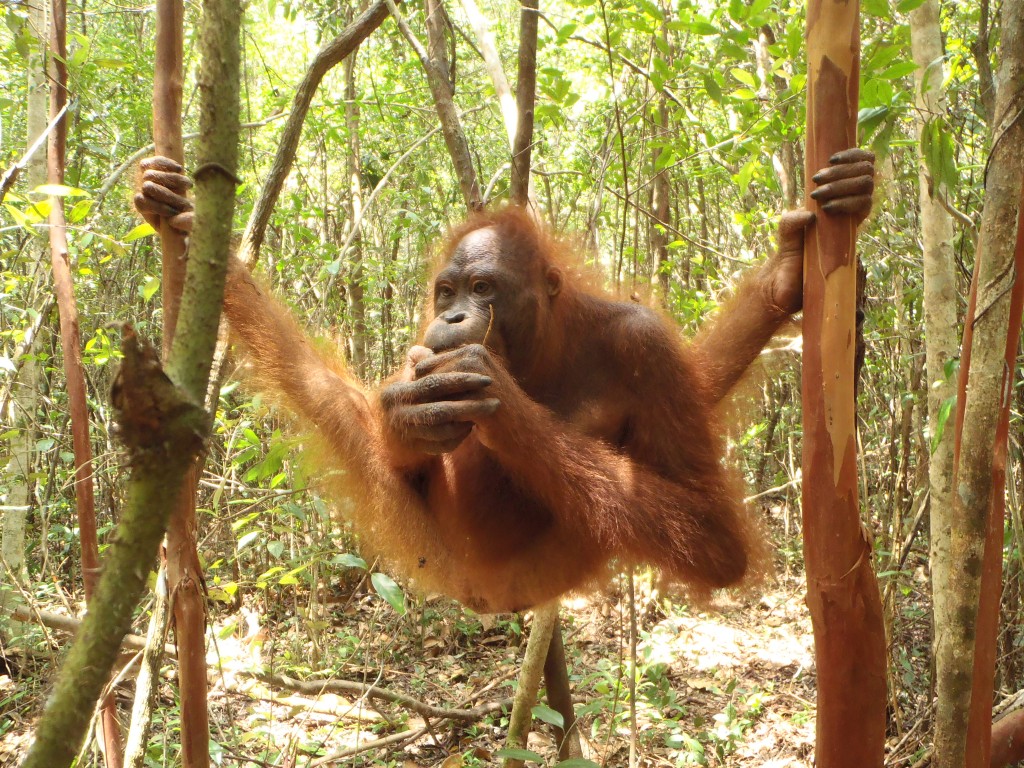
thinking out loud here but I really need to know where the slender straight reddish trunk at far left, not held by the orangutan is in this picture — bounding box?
[47,0,122,768]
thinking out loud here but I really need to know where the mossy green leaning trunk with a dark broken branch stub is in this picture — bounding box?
[24,0,236,768]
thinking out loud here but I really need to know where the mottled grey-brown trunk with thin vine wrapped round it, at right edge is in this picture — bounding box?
[935,0,1024,768]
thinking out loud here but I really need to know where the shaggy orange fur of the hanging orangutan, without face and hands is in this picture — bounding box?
[218,208,774,611]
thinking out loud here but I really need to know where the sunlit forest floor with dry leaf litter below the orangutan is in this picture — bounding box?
[0,561,933,768]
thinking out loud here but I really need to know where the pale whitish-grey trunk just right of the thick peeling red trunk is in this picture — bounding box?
[910,0,959,733]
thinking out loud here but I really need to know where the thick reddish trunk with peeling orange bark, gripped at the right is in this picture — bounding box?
[803,0,886,768]
